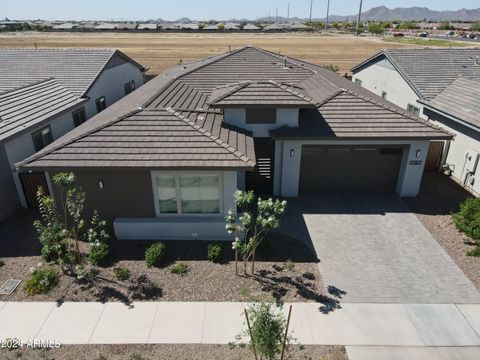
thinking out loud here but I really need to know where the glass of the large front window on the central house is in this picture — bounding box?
[154,174,220,214]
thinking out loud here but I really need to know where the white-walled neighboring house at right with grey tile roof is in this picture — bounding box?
[352,48,480,194]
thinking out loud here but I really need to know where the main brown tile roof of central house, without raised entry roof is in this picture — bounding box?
[19,47,451,168]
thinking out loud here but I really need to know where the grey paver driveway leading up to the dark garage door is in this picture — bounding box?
[282,194,480,304]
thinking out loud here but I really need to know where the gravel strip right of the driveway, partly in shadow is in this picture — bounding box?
[404,172,480,289]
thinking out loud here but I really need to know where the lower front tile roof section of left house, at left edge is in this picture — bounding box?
[0,78,86,141]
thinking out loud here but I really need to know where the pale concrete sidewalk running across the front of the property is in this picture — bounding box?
[0,302,480,352]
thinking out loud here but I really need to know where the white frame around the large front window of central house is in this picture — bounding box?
[150,171,224,218]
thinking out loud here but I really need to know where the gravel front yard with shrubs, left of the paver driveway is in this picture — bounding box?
[0,210,332,303]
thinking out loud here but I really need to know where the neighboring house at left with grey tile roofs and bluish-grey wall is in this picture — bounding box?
[0,49,145,220]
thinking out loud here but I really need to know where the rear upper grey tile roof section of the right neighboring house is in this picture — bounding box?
[352,48,480,100]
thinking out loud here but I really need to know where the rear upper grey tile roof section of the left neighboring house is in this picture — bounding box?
[0,48,141,96]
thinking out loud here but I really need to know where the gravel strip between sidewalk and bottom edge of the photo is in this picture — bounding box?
[0,344,348,360]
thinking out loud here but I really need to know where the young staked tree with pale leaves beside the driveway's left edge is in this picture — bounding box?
[225,190,287,274]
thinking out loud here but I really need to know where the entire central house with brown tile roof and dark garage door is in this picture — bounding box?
[17,47,451,240]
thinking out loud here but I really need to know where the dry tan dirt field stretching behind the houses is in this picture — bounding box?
[0,32,411,74]
